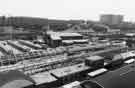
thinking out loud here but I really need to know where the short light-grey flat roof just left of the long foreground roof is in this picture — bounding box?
[31,72,57,85]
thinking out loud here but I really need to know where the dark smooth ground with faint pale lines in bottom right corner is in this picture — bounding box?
[89,63,135,88]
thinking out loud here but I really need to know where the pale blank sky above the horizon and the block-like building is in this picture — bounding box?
[0,0,135,22]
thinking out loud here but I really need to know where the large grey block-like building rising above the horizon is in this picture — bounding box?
[100,14,124,25]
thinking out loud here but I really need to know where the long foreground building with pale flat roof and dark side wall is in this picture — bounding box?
[49,63,92,83]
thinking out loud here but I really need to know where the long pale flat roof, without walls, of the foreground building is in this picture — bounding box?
[49,63,90,77]
